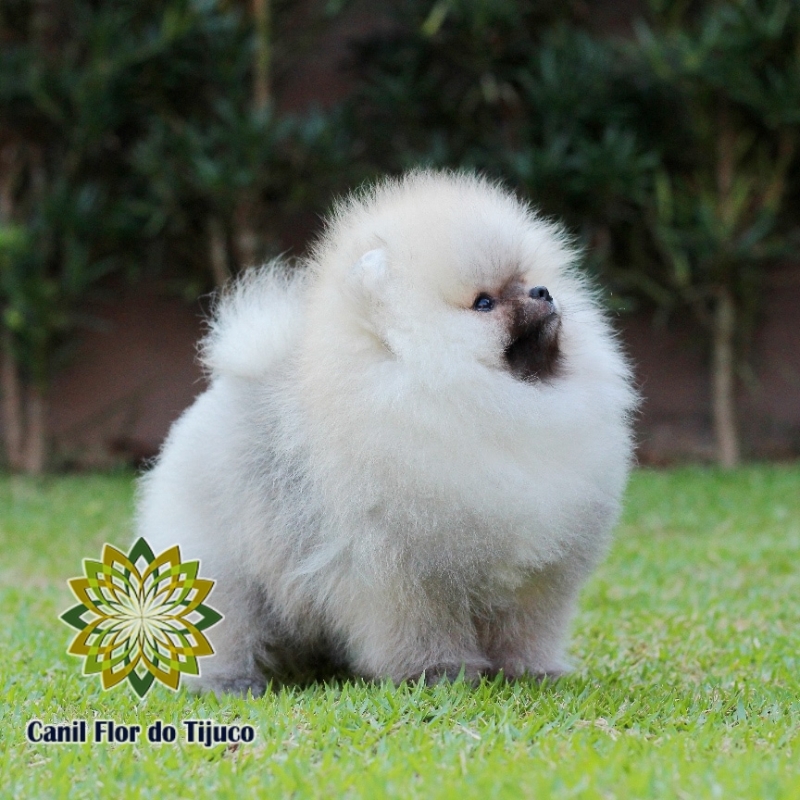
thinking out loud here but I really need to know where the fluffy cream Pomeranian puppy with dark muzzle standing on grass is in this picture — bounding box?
[138,171,636,694]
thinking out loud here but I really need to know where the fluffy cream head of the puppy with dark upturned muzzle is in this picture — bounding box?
[316,172,579,382]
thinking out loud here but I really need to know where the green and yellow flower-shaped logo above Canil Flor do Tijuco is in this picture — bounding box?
[61,539,222,697]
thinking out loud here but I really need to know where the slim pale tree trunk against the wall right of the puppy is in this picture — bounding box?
[712,287,740,469]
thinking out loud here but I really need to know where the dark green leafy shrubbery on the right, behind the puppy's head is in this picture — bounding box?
[352,0,800,465]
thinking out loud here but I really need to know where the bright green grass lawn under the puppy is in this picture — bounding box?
[0,466,800,800]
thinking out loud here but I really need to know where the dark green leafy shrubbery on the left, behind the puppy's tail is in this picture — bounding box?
[0,0,350,471]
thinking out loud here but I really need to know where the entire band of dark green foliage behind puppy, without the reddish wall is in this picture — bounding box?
[0,0,800,471]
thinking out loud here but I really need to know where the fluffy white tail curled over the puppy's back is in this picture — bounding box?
[199,259,305,378]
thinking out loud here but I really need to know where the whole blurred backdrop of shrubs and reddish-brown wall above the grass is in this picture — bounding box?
[0,0,800,473]
